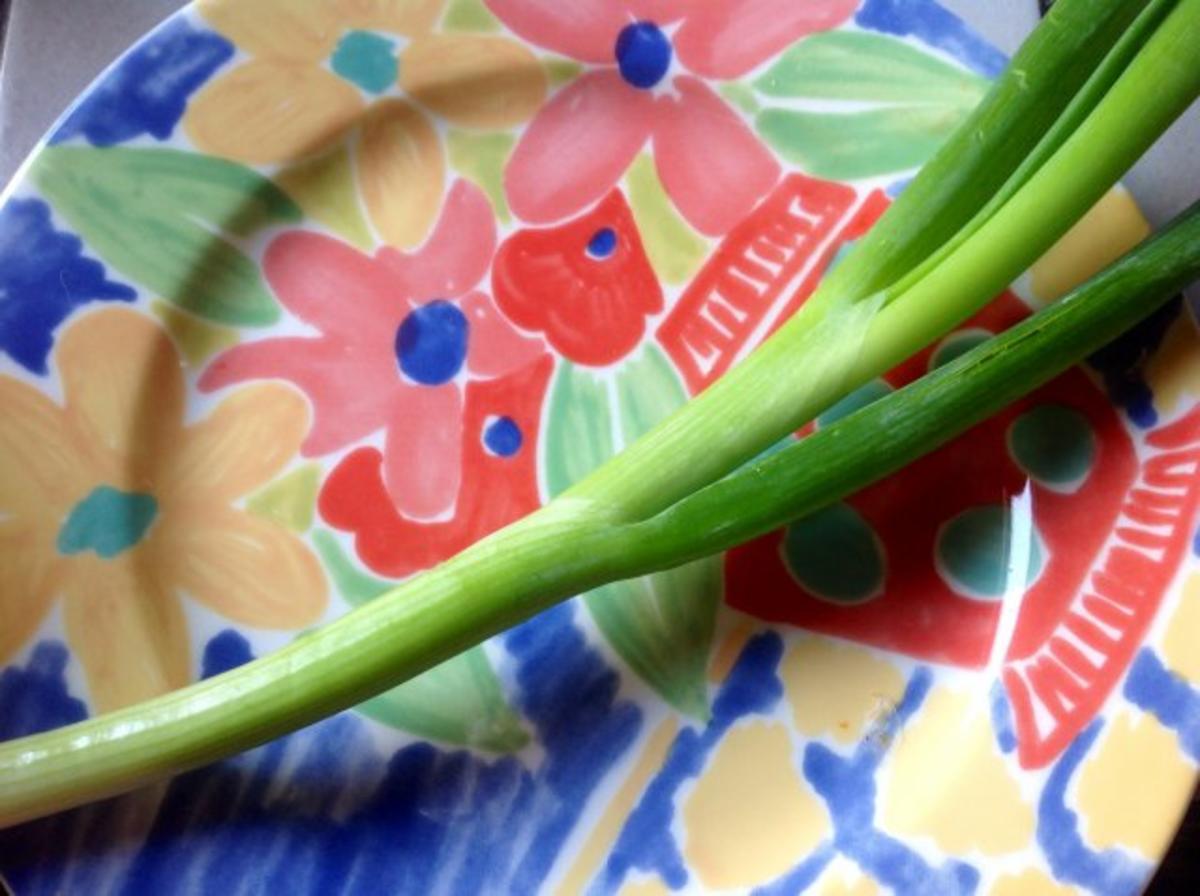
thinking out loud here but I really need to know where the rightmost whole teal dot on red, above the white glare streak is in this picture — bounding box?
[1008,404,1096,492]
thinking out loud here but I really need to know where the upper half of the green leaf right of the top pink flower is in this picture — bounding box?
[754,31,988,107]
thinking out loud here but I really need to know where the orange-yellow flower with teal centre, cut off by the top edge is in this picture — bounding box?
[184,0,546,248]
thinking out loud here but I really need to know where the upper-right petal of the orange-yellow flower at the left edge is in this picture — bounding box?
[160,383,308,507]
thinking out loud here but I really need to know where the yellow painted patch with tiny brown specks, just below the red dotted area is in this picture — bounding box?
[780,636,905,744]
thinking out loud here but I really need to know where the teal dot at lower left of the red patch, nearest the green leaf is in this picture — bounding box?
[782,504,884,603]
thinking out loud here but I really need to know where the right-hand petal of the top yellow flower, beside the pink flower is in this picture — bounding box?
[400,35,546,130]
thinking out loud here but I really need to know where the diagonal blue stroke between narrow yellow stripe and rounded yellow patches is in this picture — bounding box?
[592,632,784,894]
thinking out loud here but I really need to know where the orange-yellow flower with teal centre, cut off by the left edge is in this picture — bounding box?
[0,308,326,711]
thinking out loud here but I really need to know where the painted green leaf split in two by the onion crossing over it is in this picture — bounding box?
[544,345,721,718]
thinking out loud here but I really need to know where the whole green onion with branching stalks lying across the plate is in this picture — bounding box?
[0,0,1200,826]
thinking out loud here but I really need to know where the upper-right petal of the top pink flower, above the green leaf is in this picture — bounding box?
[674,0,859,80]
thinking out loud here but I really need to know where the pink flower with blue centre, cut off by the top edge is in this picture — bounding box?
[486,0,858,235]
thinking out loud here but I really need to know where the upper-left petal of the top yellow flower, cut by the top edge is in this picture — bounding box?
[198,0,342,62]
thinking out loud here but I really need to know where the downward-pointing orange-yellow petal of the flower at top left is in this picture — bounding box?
[358,100,445,248]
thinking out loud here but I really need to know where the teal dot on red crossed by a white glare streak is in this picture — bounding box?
[934,504,1045,600]
